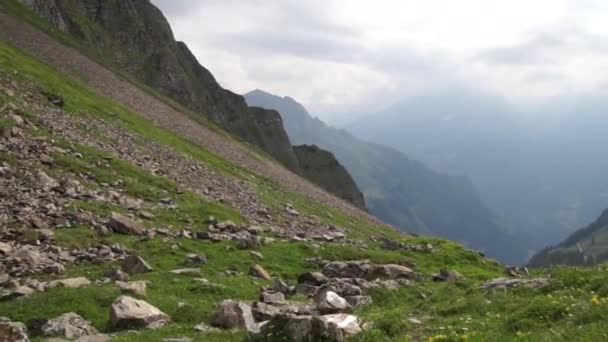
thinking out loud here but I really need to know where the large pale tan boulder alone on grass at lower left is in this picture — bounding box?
[110,296,171,330]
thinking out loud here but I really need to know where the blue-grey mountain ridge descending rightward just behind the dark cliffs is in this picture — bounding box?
[245,90,528,263]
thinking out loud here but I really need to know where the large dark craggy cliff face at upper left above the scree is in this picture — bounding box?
[20,0,298,172]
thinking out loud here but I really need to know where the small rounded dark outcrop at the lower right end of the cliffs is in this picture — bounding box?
[294,145,365,210]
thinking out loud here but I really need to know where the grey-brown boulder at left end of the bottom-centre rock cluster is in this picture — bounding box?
[211,300,259,333]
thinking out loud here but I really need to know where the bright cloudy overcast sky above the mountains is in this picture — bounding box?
[152,0,608,121]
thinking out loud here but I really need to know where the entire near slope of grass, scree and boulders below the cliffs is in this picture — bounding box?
[0,0,608,342]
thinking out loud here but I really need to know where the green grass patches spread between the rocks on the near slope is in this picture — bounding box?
[0,8,608,341]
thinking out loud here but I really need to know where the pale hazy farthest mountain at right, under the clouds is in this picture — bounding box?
[348,90,608,250]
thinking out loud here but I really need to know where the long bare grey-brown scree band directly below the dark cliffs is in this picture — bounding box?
[0,3,379,226]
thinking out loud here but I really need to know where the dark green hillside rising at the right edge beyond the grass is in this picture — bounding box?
[528,210,608,267]
